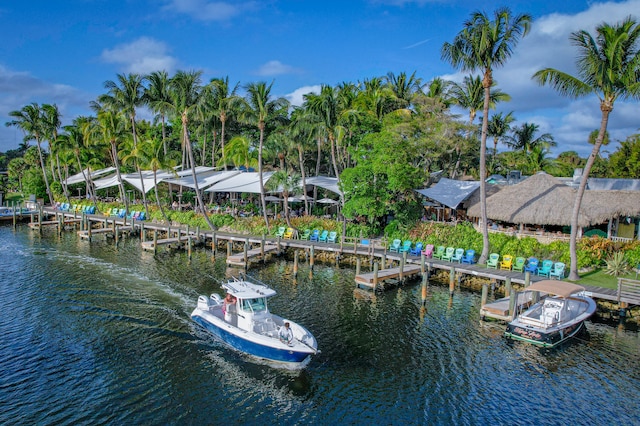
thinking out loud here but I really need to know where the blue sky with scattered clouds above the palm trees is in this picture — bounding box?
[0,0,640,157]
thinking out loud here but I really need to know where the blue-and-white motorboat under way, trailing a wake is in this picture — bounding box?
[191,279,318,363]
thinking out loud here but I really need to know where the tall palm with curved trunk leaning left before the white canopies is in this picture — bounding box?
[170,71,216,230]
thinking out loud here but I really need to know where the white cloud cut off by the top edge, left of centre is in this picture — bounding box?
[164,0,258,21]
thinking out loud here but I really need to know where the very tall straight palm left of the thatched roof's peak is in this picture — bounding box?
[442,8,532,262]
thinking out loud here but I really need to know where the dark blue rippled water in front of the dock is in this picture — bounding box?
[0,227,640,425]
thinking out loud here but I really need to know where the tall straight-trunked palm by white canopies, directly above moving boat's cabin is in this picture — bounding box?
[243,82,289,231]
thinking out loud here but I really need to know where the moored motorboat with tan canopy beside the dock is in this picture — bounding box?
[505,280,596,347]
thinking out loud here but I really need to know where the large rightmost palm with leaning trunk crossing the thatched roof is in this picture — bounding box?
[533,17,640,280]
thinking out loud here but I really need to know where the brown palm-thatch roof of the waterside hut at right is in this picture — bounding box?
[467,173,640,227]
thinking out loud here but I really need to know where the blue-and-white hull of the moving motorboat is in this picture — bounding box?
[191,309,316,364]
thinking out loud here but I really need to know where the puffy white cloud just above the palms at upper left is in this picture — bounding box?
[100,37,177,74]
